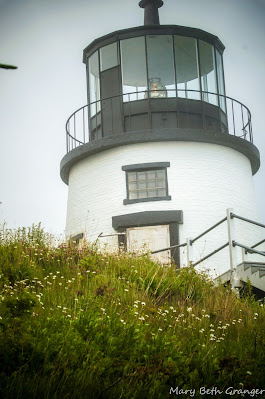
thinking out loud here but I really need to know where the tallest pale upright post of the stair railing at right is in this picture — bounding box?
[226,208,240,289]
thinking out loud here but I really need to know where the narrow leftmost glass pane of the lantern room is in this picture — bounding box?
[88,51,100,117]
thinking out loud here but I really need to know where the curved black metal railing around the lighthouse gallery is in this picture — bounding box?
[66,89,253,152]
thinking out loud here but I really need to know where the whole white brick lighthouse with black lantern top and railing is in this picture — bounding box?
[60,0,263,275]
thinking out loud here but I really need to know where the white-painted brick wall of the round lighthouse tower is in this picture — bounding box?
[66,142,264,275]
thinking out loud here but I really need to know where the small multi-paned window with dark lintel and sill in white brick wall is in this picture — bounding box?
[122,162,171,205]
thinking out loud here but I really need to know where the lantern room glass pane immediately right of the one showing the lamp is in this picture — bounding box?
[174,36,200,100]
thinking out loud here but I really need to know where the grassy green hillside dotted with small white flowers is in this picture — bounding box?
[0,226,265,399]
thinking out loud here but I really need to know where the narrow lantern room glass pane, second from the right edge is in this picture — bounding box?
[199,40,218,105]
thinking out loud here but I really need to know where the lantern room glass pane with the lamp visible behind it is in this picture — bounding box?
[146,35,176,98]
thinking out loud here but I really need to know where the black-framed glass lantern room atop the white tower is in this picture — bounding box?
[83,25,228,141]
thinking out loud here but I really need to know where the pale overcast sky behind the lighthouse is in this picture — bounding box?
[0,0,265,233]
